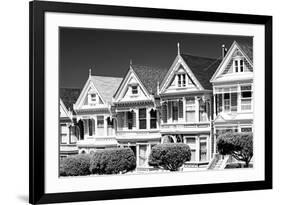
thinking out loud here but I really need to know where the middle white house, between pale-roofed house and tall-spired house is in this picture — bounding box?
[113,64,167,170]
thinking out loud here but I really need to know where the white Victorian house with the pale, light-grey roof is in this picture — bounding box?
[73,70,122,153]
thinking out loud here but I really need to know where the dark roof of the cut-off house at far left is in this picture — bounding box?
[60,88,81,111]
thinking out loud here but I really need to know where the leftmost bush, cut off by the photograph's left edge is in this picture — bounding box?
[60,154,90,176]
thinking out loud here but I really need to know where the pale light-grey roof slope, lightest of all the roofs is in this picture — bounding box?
[90,76,122,103]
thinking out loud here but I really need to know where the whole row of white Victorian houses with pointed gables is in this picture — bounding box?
[60,41,253,169]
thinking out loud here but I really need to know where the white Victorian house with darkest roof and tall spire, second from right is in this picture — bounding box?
[159,44,221,166]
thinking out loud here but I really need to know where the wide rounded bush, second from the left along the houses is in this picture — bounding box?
[90,148,136,174]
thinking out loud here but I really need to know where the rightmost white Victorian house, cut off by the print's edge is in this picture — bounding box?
[210,41,254,153]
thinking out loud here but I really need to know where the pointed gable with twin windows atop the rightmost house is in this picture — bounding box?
[210,41,253,83]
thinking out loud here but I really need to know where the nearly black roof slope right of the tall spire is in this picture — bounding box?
[181,54,221,90]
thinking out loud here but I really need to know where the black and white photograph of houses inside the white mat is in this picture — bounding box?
[59,27,256,178]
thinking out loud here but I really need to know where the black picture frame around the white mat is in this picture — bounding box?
[29,1,272,204]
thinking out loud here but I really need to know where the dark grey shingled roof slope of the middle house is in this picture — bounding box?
[131,65,168,94]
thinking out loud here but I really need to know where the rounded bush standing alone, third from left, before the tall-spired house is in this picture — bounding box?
[148,143,191,171]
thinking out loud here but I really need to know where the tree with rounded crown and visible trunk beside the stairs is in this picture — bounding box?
[217,132,253,167]
